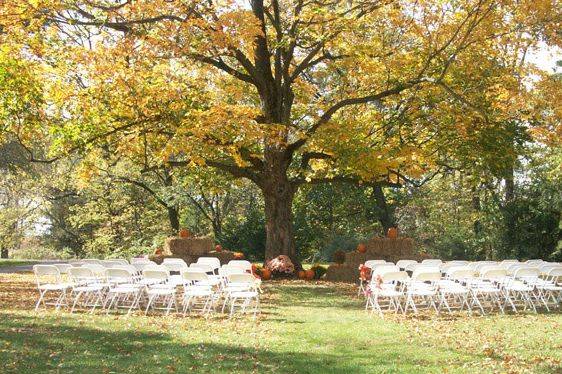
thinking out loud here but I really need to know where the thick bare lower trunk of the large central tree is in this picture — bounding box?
[262,174,300,267]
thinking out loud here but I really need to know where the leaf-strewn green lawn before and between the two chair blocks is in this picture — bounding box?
[0,274,562,373]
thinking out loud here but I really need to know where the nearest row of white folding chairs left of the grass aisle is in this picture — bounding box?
[34,264,259,316]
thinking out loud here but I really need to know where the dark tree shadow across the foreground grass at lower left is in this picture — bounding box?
[0,313,492,373]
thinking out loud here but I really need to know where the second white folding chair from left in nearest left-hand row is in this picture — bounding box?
[68,267,106,313]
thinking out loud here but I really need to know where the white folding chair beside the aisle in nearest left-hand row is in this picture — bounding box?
[224,273,260,317]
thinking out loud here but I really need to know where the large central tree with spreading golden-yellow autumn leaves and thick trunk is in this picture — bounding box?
[0,0,561,258]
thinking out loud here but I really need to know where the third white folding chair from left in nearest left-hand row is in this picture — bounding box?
[104,268,143,315]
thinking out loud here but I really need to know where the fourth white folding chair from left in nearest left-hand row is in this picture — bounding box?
[142,269,178,315]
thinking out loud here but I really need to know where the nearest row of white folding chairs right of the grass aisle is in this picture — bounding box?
[366,267,562,315]
